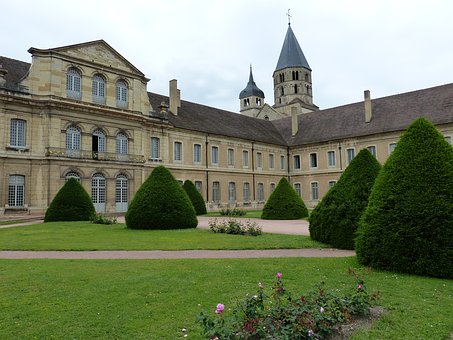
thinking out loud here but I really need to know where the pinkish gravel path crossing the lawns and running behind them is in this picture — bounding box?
[0,216,355,259]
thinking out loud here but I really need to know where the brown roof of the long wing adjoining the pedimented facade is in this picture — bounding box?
[148,92,286,145]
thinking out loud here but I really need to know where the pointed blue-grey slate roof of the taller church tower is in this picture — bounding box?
[275,25,311,71]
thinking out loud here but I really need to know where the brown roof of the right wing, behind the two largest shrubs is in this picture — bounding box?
[273,84,453,146]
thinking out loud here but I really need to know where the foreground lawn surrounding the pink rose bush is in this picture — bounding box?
[0,257,453,340]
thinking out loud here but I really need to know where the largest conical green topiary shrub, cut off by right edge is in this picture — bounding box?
[356,118,453,278]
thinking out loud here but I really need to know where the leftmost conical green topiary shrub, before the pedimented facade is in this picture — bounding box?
[44,178,96,222]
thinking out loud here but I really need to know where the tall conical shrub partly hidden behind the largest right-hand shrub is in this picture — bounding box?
[309,149,381,249]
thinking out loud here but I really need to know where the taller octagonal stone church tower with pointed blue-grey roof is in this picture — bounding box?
[273,22,318,116]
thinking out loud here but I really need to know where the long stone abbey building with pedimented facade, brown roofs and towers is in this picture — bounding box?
[0,26,453,214]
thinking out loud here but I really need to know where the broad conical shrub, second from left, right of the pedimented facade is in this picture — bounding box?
[125,166,198,229]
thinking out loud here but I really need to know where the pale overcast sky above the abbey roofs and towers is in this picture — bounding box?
[0,0,453,112]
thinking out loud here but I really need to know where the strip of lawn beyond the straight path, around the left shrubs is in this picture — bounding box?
[0,222,327,250]
